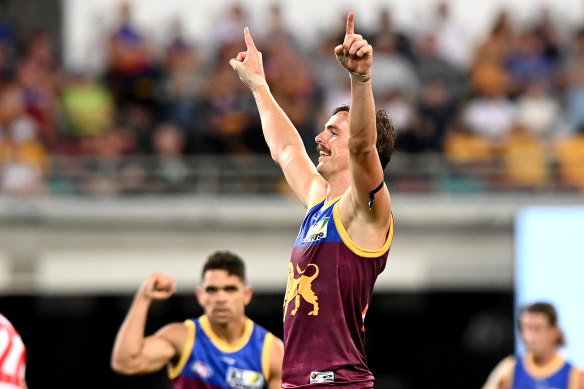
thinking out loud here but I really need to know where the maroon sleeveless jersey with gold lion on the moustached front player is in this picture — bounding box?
[282,197,393,389]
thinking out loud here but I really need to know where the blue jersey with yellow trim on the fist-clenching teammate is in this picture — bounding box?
[169,315,274,389]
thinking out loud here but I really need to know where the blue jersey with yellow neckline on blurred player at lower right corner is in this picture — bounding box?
[512,355,580,389]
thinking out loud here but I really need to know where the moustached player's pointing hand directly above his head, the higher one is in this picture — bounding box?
[335,12,373,76]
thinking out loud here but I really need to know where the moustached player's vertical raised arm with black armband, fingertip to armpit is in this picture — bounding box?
[335,12,391,232]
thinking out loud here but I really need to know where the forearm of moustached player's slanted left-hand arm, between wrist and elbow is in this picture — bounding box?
[253,87,304,166]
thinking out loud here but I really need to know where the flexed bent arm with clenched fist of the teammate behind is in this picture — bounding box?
[111,274,188,374]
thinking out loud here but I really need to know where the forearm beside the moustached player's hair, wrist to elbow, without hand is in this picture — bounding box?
[349,80,377,154]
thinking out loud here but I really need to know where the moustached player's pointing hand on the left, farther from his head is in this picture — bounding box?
[229,27,268,91]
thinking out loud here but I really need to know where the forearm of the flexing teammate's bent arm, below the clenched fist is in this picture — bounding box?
[111,294,151,373]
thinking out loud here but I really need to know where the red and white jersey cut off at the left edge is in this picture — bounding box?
[0,314,26,389]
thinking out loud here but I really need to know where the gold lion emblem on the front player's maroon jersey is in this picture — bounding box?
[284,262,318,321]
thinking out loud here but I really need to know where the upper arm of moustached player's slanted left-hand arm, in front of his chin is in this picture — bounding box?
[280,147,326,207]
